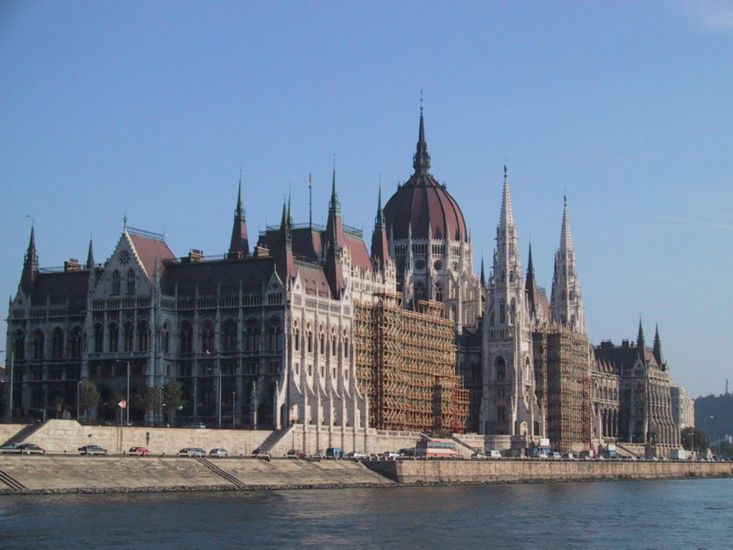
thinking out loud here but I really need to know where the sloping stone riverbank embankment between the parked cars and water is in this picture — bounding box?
[0,455,733,494]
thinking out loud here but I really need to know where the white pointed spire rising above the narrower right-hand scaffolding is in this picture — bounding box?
[550,197,586,334]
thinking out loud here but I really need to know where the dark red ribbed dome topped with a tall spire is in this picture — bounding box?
[384,110,468,241]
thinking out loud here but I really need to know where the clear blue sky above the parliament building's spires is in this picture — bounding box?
[0,0,733,396]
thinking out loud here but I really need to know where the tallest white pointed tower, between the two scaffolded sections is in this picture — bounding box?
[481,166,544,444]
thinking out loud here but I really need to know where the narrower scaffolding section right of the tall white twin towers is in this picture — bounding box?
[533,324,592,452]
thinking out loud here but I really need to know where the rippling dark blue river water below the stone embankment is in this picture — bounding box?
[0,479,733,548]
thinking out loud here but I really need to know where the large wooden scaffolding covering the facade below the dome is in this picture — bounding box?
[354,293,469,434]
